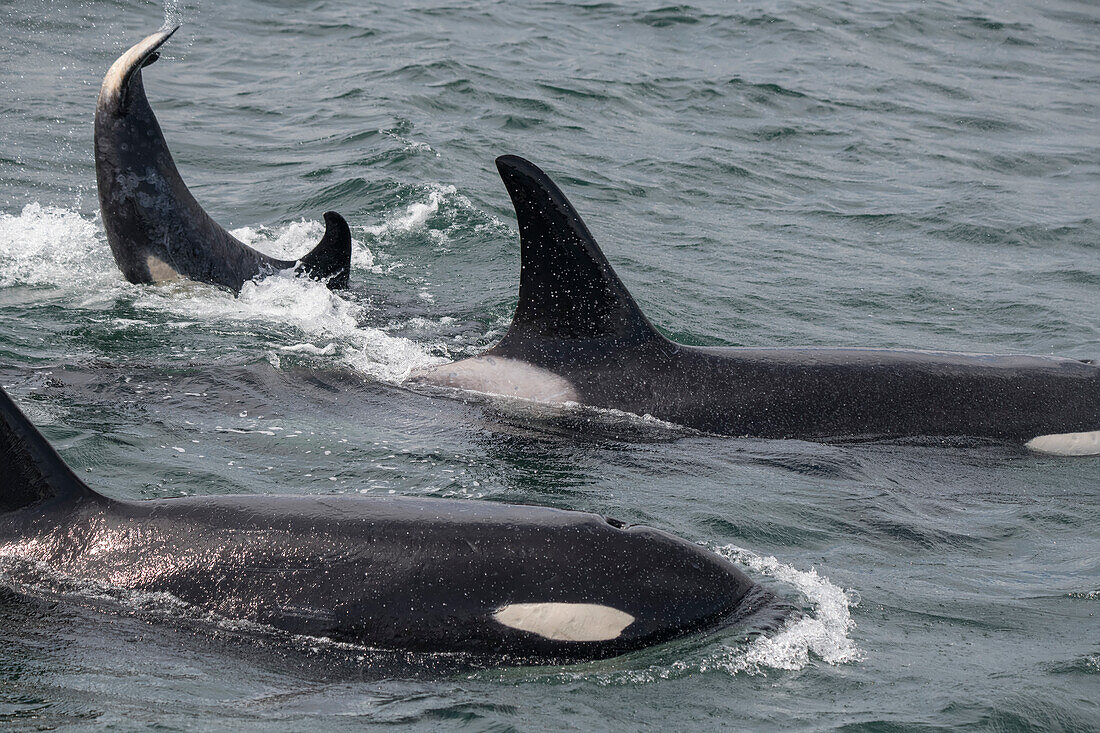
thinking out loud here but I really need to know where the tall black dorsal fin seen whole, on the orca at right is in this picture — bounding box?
[493,155,663,355]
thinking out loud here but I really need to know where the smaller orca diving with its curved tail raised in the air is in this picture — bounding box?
[96,25,351,292]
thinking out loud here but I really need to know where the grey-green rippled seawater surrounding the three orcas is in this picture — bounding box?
[0,0,1100,731]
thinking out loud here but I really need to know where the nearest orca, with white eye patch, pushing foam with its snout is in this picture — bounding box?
[0,390,765,664]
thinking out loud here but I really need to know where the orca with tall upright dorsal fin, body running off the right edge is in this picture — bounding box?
[406,155,1100,455]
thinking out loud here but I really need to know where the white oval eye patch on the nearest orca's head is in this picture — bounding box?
[493,603,634,642]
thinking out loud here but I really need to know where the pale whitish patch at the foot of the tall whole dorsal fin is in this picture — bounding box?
[408,357,580,404]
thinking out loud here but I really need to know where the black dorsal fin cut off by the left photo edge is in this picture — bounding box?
[0,390,98,513]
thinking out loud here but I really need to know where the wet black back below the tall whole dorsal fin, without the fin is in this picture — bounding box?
[506,338,1100,442]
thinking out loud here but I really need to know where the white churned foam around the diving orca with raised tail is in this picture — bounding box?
[0,204,446,382]
